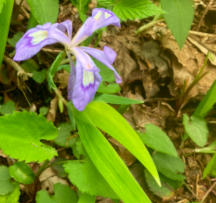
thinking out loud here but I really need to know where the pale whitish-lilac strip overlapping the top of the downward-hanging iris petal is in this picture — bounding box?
[72,47,99,72]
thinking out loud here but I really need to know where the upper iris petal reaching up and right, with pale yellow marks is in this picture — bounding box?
[72,8,120,46]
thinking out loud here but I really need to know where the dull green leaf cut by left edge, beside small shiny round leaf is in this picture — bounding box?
[0,166,14,195]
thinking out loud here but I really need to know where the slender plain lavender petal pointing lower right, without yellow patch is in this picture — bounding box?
[79,46,122,83]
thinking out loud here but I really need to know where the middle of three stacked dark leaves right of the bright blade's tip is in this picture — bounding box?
[152,152,185,181]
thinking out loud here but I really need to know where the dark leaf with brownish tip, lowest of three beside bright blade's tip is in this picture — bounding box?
[144,170,174,201]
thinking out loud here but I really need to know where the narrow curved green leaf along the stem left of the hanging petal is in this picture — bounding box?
[47,51,66,91]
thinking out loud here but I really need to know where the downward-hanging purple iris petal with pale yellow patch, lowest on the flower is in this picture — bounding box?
[72,60,101,111]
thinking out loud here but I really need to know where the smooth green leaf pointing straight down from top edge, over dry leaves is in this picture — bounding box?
[160,0,194,49]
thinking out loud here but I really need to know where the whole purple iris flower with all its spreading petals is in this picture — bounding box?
[13,8,122,111]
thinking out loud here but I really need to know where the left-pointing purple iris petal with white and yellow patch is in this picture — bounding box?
[13,23,70,61]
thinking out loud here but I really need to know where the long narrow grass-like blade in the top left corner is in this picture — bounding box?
[0,0,14,66]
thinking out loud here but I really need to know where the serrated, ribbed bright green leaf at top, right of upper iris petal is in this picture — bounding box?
[113,0,164,20]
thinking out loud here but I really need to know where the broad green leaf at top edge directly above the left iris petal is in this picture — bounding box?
[27,0,59,25]
